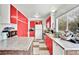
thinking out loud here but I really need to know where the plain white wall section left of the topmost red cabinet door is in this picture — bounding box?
[0,4,10,23]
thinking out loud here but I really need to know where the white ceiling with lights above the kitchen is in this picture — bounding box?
[13,4,77,18]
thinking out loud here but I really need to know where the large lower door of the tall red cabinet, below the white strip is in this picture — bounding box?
[18,21,28,37]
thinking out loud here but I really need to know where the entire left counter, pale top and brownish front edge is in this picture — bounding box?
[0,36,34,55]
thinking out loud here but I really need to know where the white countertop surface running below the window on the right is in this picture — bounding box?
[46,33,79,50]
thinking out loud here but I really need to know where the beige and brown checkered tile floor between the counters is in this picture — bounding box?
[33,39,49,55]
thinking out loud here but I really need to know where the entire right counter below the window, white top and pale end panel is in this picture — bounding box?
[46,33,79,55]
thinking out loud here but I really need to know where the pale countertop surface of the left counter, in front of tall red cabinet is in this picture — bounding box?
[0,37,34,51]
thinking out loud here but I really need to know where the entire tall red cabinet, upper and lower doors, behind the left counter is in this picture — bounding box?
[17,11,28,37]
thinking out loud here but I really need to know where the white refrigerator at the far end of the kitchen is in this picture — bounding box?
[35,24,42,39]
